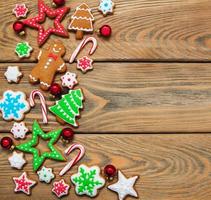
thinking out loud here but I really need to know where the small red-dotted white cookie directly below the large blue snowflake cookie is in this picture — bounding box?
[11,122,29,139]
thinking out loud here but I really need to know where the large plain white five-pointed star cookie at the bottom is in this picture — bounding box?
[108,171,138,200]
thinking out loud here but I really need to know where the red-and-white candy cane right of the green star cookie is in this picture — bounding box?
[59,144,85,176]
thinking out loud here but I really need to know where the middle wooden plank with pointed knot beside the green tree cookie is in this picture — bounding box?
[0,63,211,133]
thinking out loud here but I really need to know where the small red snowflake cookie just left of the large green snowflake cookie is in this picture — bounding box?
[52,179,70,198]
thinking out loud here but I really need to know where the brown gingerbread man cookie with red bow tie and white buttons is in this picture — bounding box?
[29,40,67,90]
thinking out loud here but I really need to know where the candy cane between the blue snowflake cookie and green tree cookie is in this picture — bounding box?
[29,90,48,124]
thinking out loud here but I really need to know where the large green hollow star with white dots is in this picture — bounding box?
[16,121,65,171]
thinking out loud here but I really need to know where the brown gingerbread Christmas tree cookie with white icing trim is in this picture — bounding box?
[69,3,94,40]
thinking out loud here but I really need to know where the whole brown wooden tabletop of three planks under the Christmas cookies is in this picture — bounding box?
[0,0,211,200]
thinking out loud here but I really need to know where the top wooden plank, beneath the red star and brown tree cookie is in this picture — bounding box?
[0,0,211,62]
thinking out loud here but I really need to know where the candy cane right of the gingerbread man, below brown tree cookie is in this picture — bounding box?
[69,37,97,63]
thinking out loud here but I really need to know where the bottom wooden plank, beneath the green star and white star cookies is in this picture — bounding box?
[0,134,211,200]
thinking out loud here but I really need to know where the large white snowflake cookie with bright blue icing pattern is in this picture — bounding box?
[0,90,30,121]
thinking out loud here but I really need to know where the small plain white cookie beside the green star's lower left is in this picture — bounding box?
[8,151,26,169]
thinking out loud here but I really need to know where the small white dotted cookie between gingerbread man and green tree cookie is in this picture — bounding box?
[61,72,78,89]
